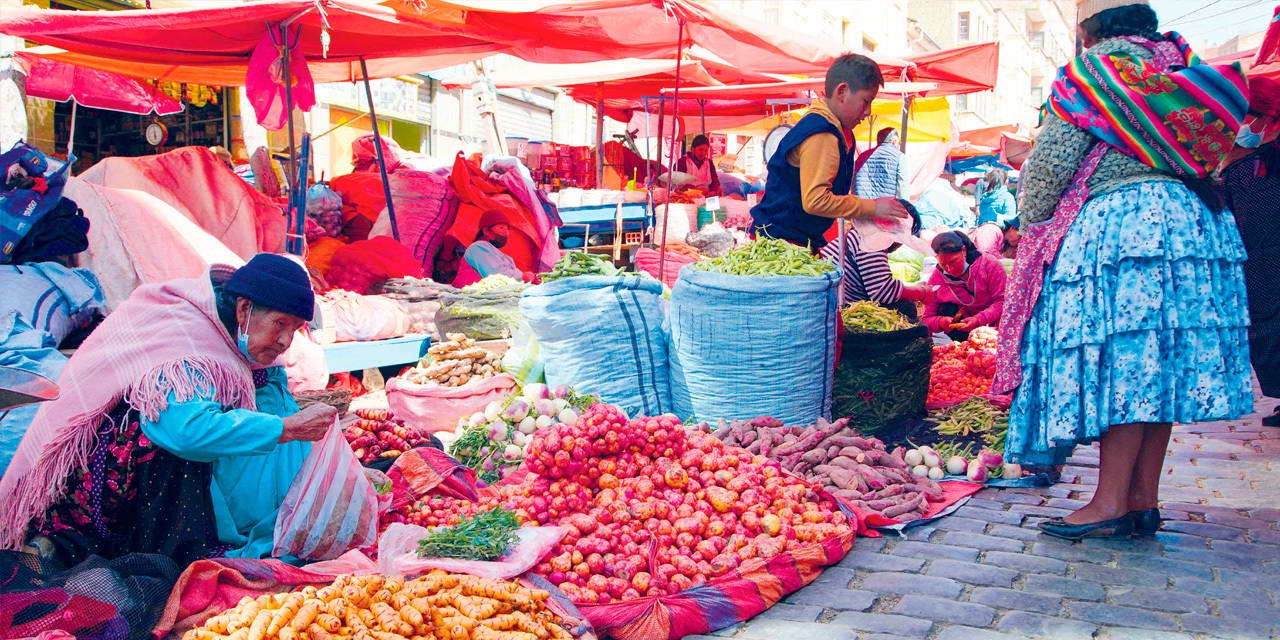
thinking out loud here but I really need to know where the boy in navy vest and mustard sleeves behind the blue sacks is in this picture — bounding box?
[751,54,909,253]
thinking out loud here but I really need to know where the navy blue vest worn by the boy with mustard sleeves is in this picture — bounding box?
[751,113,854,251]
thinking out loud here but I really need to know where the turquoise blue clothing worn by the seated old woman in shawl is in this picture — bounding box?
[142,367,311,558]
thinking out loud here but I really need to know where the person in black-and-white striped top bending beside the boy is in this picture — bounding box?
[820,198,929,321]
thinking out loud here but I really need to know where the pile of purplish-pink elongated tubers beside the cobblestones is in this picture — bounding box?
[712,417,943,521]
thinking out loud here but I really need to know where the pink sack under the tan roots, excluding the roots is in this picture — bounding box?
[387,374,516,434]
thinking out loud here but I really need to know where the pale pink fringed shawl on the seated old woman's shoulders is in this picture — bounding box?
[0,274,255,549]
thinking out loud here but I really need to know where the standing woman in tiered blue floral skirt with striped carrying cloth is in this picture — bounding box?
[995,0,1253,539]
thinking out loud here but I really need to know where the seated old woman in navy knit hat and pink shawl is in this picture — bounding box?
[0,253,335,564]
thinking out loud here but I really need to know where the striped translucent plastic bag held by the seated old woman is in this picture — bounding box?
[271,417,378,559]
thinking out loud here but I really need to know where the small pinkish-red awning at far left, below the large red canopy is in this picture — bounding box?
[14,51,183,115]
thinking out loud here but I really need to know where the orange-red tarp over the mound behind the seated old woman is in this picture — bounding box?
[79,147,285,260]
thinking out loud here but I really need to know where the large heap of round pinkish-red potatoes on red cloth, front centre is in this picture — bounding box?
[384,403,854,640]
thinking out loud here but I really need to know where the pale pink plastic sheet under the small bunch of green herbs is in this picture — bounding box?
[378,522,568,580]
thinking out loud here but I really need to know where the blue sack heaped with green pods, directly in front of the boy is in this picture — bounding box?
[668,238,841,424]
